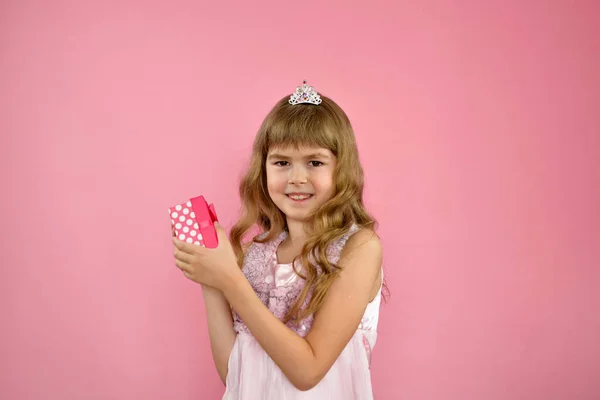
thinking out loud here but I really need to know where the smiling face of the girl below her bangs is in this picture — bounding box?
[266,147,337,224]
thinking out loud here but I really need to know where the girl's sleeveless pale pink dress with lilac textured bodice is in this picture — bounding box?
[223,226,383,400]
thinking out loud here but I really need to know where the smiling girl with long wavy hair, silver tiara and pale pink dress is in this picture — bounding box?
[173,82,383,400]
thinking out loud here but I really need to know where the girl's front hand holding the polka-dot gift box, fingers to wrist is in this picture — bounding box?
[173,223,243,291]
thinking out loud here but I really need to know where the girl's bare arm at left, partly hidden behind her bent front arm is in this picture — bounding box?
[202,285,236,384]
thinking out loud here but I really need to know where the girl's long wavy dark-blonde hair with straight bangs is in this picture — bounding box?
[230,95,376,322]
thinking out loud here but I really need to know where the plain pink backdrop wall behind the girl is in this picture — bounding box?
[0,0,600,400]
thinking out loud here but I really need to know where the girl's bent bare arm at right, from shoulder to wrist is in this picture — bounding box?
[224,230,382,390]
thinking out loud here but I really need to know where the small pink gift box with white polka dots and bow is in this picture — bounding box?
[169,196,219,248]
